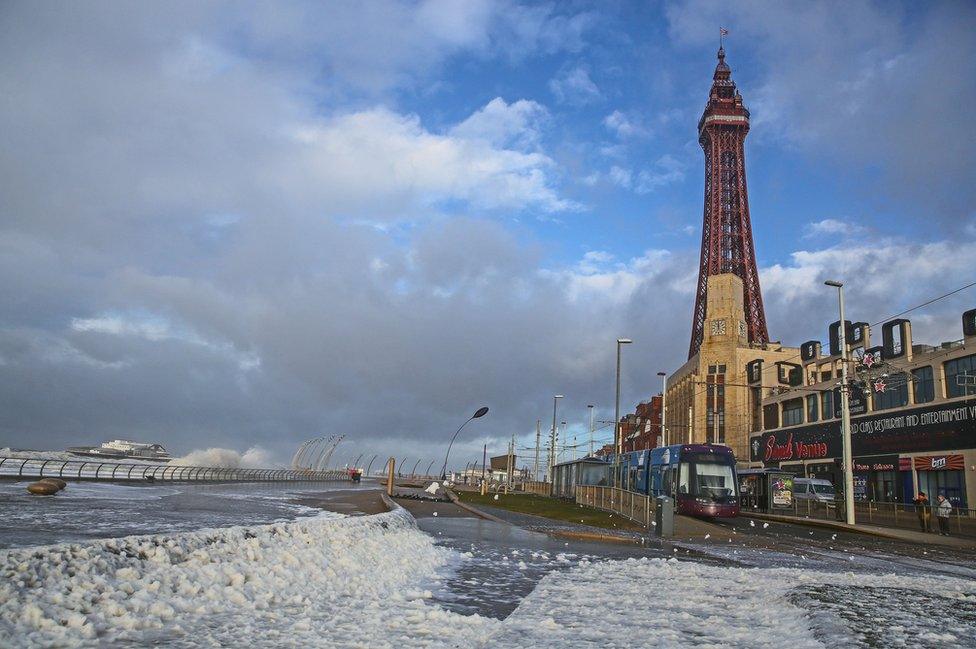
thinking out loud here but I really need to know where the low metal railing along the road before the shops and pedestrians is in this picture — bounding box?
[742,498,976,537]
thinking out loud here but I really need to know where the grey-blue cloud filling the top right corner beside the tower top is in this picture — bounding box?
[666,0,976,230]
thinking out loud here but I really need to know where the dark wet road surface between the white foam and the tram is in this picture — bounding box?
[400,494,976,620]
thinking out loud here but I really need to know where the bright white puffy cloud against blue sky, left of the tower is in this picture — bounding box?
[294,105,574,216]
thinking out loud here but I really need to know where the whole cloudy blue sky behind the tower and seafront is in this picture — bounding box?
[0,0,976,468]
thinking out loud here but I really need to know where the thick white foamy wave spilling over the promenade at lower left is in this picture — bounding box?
[0,510,492,647]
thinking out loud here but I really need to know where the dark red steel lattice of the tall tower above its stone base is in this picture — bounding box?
[688,47,769,358]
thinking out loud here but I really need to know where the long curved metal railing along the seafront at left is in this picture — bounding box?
[0,457,351,482]
